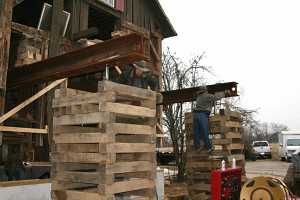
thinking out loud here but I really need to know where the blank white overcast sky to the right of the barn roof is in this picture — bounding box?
[160,0,300,130]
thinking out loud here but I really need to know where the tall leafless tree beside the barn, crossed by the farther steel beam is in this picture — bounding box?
[162,49,211,181]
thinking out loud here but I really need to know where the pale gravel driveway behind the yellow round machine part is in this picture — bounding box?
[246,160,291,180]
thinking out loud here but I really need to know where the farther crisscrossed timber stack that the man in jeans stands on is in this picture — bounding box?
[185,111,245,200]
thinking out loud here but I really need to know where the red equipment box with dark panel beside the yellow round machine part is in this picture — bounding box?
[211,168,242,200]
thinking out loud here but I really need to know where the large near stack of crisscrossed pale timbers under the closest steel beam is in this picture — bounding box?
[51,81,156,200]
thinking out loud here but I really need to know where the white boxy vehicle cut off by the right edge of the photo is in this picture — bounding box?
[278,131,300,160]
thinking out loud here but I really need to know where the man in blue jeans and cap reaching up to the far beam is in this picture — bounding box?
[193,87,225,152]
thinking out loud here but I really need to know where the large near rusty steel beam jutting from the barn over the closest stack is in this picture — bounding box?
[7,33,149,89]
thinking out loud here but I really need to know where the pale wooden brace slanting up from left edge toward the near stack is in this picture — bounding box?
[0,79,66,123]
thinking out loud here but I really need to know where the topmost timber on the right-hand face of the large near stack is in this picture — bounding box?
[98,81,156,101]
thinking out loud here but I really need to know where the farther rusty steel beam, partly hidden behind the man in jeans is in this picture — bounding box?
[158,82,238,105]
